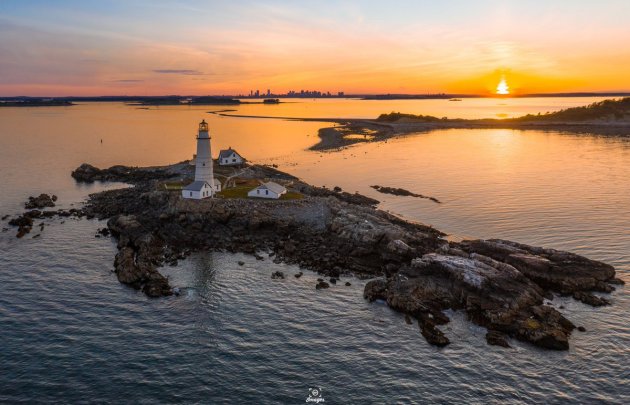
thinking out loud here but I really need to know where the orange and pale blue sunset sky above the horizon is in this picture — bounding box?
[0,0,630,96]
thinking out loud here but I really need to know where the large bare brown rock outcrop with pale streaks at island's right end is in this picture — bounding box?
[364,240,614,350]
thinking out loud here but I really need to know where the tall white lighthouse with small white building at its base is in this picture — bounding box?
[182,120,221,200]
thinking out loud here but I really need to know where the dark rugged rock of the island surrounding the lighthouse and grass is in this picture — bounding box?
[3,162,622,350]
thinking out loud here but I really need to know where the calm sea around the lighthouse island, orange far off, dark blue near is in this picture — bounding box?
[0,98,630,404]
